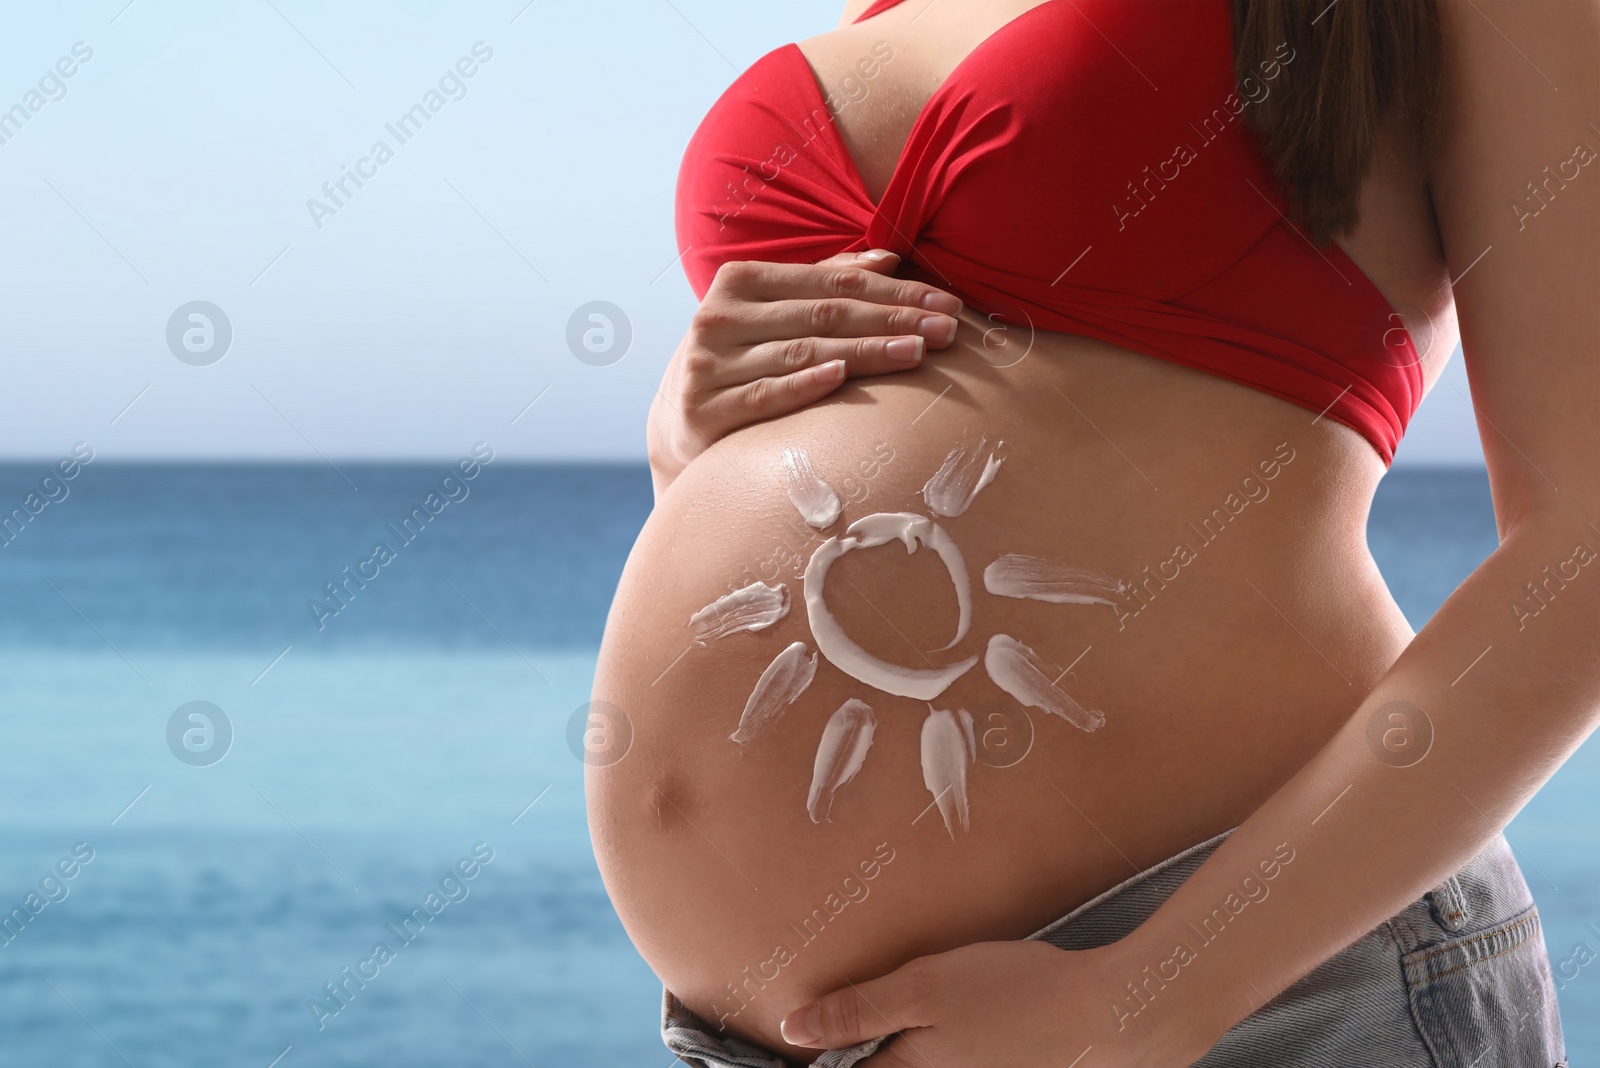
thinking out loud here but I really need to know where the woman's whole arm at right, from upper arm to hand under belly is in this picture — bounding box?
[787,0,1600,1068]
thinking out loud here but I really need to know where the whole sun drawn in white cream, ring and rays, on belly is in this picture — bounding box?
[690,438,1123,838]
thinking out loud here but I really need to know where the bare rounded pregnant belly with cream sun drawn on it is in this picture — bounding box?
[587,322,1410,1050]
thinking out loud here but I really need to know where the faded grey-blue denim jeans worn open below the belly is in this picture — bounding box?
[661,831,1565,1068]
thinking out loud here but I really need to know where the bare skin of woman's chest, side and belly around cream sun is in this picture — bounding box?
[587,0,1456,1063]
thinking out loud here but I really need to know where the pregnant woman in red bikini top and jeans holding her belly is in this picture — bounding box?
[587,0,1600,1068]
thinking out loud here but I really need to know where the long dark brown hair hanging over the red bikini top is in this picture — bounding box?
[1234,0,1443,245]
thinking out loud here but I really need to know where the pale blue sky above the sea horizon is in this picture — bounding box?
[0,0,1482,464]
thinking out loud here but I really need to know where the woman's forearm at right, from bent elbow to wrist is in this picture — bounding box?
[1120,508,1600,1055]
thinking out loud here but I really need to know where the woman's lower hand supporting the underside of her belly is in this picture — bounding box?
[782,940,1216,1068]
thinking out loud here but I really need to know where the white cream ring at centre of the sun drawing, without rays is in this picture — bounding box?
[805,512,978,700]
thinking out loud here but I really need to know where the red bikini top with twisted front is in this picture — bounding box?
[677,0,1422,465]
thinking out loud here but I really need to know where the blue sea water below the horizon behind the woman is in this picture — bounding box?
[0,462,1600,1068]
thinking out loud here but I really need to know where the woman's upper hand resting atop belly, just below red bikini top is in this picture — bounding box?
[645,249,962,494]
